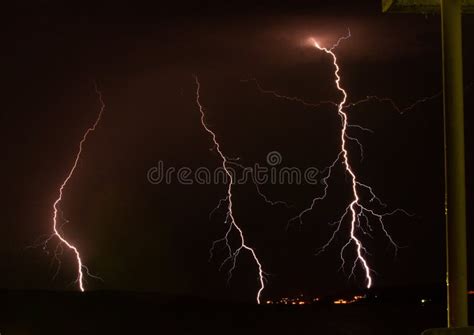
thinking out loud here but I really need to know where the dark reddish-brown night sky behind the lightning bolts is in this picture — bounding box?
[0,0,474,301]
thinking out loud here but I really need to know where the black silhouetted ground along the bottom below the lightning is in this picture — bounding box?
[0,291,473,335]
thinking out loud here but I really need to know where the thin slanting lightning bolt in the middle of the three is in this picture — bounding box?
[194,76,265,304]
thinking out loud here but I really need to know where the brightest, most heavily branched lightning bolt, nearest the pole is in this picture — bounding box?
[242,31,426,288]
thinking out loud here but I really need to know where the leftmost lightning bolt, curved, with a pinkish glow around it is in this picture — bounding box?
[44,85,105,292]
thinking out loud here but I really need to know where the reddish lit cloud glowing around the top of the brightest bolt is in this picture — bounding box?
[265,13,439,62]
